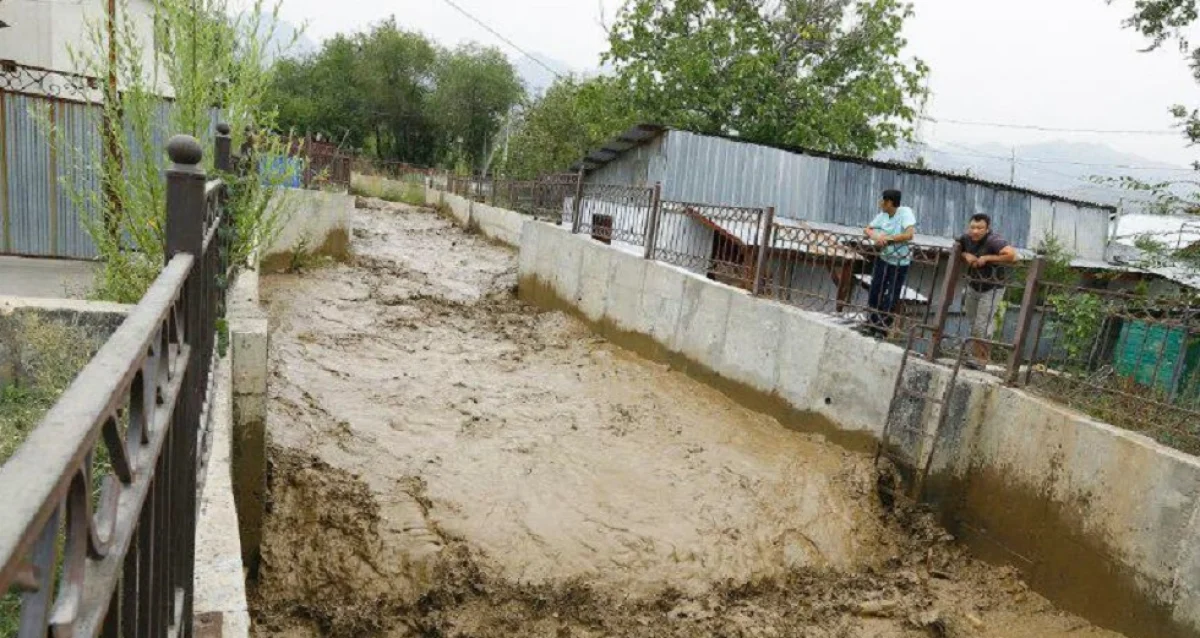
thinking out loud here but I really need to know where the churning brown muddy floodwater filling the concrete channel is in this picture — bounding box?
[252,200,1117,638]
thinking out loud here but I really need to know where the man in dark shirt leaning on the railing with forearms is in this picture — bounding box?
[959,213,1016,368]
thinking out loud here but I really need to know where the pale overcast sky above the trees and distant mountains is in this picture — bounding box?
[270,0,1200,164]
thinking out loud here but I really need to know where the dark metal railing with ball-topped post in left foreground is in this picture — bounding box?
[0,126,232,637]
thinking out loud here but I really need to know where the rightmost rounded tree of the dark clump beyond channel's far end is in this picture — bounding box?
[430,44,524,168]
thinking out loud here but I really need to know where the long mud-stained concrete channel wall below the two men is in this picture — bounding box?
[518,218,1200,638]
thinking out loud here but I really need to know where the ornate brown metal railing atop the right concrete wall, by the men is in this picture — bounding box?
[436,176,1200,453]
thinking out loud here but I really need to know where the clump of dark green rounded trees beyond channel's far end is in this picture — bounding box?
[269,19,524,167]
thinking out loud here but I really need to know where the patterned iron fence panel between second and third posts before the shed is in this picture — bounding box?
[650,201,767,289]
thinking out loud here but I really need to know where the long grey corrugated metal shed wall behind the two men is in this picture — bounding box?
[609,131,1109,259]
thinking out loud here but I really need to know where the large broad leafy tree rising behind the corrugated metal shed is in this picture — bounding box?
[605,0,928,156]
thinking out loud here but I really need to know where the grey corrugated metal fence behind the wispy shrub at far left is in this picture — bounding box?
[0,92,220,259]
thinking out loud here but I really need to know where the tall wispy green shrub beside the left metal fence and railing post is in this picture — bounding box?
[53,0,300,303]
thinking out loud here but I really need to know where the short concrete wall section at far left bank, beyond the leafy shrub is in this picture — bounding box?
[262,188,354,272]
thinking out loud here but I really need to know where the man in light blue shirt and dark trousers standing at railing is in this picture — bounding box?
[863,189,917,337]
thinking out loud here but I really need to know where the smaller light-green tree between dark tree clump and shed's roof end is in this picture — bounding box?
[503,78,640,179]
